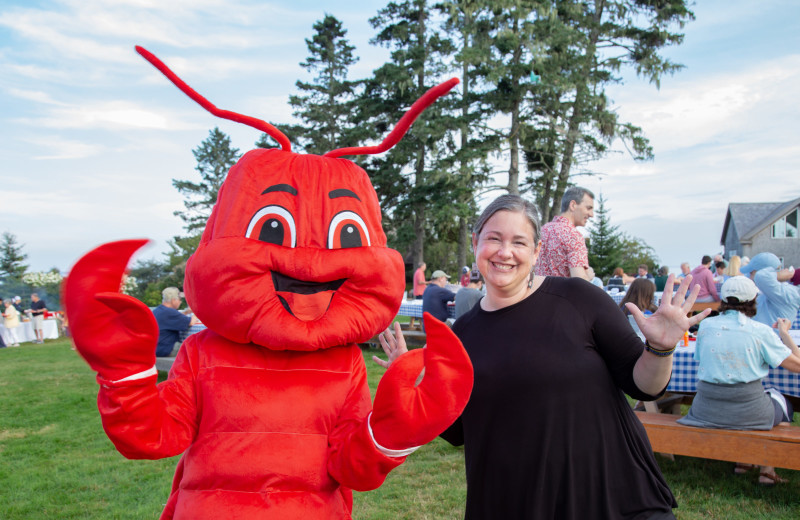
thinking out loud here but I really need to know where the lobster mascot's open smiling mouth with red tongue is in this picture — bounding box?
[272,271,346,321]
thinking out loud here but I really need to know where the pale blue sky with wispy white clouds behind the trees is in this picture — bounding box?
[0,0,800,271]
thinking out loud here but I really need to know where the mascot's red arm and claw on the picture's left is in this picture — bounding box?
[64,240,194,458]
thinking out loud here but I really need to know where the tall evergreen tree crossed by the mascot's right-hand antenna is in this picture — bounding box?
[359,0,453,265]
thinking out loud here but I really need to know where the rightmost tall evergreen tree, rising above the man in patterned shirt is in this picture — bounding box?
[527,0,694,221]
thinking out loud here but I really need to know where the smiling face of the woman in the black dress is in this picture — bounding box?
[472,210,539,292]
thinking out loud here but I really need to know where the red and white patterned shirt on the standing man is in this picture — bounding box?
[536,215,589,278]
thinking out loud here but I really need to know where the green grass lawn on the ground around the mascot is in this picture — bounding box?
[0,340,800,520]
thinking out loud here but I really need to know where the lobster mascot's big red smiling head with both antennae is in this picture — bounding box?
[137,47,458,350]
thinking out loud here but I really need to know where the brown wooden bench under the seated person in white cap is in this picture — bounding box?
[634,412,800,470]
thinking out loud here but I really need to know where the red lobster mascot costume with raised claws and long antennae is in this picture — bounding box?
[64,47,472,520]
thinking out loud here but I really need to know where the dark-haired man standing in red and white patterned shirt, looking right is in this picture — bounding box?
[536,186,594,281]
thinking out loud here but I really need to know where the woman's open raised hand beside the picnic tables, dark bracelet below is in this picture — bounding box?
[625,274,711,350]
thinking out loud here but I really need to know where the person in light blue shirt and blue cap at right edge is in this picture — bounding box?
[739,253,800,325]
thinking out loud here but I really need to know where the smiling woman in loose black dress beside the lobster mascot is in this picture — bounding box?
[422,195,699,519]
